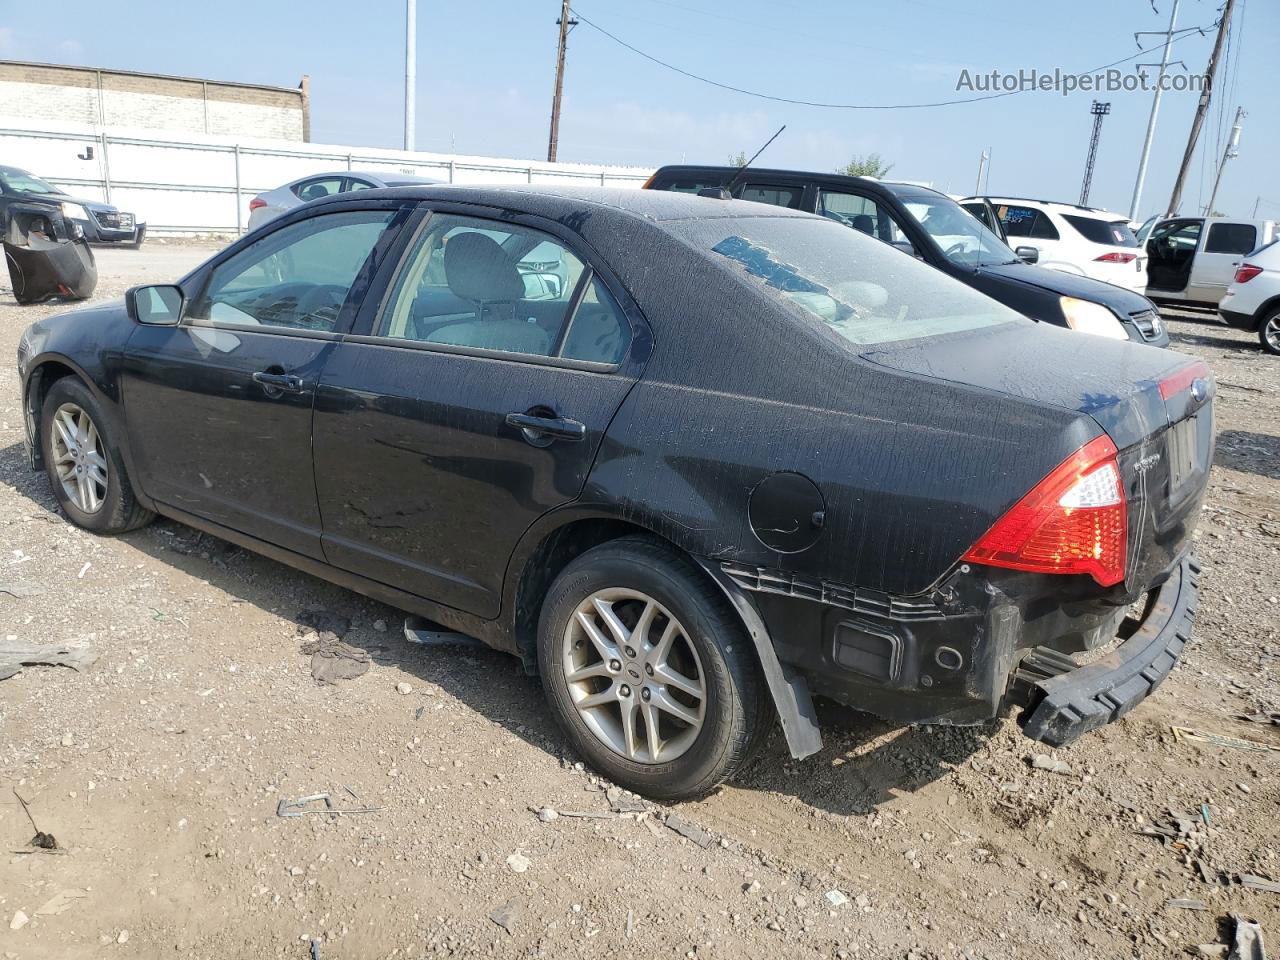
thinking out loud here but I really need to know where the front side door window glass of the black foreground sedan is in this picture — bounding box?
[189,210,394,332]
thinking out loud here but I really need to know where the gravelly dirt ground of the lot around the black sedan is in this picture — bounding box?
[0,244,1280,960]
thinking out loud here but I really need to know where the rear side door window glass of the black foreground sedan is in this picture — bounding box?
[380,215,630,362]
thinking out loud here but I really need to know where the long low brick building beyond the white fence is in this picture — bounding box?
[0,60,311,141]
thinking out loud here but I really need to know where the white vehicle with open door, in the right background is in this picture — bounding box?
[1143,216,1276,307]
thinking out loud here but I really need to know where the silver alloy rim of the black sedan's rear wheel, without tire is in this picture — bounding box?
[561,588,707,764]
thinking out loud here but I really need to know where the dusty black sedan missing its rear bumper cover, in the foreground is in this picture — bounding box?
[18,187,1215,797]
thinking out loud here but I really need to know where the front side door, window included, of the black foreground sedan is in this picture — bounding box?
[122,204,403,558]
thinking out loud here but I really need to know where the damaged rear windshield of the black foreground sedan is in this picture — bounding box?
[669,216,1030,346]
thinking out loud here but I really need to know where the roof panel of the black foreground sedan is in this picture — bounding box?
[305,183,820,221]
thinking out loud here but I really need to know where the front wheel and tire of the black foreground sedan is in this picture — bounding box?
[40,376,155,534]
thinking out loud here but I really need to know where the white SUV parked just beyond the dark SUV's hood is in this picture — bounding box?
[960,197,1147,293]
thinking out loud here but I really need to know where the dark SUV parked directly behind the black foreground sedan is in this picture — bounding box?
[645,165,1169,347]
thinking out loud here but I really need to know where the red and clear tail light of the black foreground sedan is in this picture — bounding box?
[964,435,1129,586]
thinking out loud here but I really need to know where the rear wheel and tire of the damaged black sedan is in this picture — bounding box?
[538,538,772,800]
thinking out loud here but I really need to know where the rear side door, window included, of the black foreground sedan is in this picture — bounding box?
[314,206,645,617]
